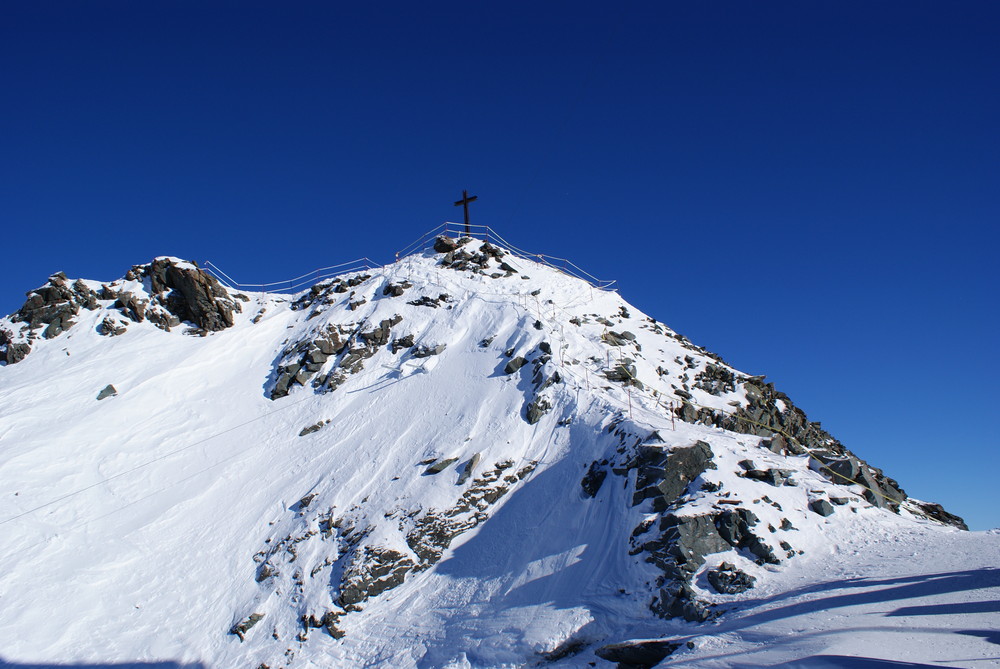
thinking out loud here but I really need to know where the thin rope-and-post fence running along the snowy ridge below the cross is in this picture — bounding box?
[204,222,615,293]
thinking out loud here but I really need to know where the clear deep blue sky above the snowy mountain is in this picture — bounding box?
[0,0,1000,529]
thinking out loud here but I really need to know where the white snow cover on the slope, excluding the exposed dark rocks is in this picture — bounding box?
[0,244,1000,669]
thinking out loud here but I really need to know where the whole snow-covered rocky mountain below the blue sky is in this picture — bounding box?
[0,231,1000,669]
